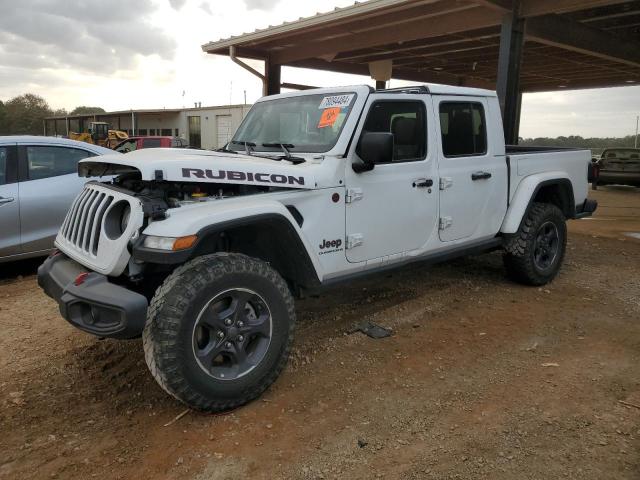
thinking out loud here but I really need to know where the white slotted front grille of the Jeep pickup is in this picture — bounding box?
[60,184,114,256]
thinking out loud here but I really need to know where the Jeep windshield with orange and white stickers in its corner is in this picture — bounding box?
[228,93,356,153]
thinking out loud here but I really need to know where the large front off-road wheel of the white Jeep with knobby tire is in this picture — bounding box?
[142,253,295,412]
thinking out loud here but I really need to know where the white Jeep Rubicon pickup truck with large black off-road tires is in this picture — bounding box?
[38,85,596,411]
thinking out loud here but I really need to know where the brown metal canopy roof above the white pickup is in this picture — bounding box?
[202,0,640,92]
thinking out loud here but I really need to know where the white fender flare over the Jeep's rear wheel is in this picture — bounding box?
[500,173,576,233]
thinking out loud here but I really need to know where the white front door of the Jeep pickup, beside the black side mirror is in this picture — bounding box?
[346,93,437,262]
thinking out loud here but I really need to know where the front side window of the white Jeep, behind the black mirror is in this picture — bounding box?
[363,101,427,162]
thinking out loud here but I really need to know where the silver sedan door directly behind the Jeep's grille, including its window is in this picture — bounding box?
[18,144,95,253]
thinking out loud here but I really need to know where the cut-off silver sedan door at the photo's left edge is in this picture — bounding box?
[0,144,20,257]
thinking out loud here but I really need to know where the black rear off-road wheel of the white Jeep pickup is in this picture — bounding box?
[503,203,567,285]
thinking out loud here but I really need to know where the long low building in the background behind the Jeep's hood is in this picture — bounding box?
[44,105,251,149]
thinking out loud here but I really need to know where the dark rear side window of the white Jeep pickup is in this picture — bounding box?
[440,102,487,157]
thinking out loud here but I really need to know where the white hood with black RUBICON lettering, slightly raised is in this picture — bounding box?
[78,148,318,189]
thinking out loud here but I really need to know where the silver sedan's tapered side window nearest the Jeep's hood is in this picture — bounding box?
[27,146,94,180]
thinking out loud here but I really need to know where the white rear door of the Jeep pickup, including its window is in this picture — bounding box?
[434,96,507,242]
